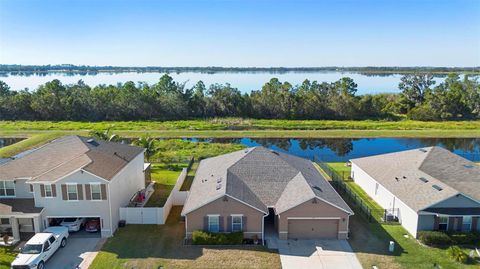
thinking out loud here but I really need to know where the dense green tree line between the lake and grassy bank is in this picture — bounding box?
[0,74,480,121]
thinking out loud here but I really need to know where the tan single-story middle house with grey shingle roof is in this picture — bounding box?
[182,147,353,239]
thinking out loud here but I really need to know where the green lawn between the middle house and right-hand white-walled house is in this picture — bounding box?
[328,163,479,269]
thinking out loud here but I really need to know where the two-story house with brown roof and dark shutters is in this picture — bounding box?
[0,136,145,240]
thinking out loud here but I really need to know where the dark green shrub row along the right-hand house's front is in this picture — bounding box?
[418,231,480,246]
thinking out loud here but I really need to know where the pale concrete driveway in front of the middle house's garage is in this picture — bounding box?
[278,240,362,269]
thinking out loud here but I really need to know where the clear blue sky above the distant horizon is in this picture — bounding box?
[0,0,480,66]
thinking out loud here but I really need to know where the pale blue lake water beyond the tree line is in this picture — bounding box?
[0,71,450,95]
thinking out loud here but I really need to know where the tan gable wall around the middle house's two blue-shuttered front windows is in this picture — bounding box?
[185,196,264,238]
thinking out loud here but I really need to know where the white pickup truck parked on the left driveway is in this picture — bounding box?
[11,227,69,269]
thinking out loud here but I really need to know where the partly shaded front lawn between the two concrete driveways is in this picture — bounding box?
[90,207,281,269]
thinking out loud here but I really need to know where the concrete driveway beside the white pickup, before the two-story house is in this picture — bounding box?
[45,234,102,269]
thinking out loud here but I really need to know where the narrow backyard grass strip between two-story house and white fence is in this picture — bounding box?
[145,163,187,207]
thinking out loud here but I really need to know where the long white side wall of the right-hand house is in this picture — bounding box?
[352,163,418,237]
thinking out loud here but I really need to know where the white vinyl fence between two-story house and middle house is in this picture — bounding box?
[120,168,188,224]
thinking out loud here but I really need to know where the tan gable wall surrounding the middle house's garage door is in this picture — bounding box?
[278,199,349,239]
